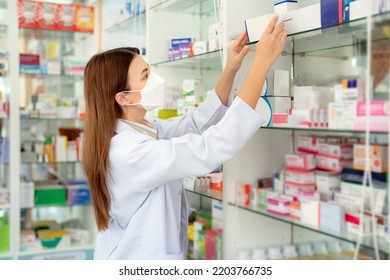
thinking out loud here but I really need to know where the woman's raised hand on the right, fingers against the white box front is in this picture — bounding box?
[254,16,287,69]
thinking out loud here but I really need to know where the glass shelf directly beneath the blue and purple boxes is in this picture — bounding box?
[151,50,222,70]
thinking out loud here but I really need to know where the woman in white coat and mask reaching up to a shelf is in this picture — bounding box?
[83,17,286,259]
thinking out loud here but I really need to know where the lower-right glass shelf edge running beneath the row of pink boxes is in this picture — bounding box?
[228,202,389,255]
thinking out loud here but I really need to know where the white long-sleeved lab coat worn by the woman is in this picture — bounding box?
[94,92,263,260]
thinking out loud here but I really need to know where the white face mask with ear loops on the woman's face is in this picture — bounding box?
[122,72,165,111]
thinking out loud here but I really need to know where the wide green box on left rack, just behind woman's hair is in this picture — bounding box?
[35,185,67,205]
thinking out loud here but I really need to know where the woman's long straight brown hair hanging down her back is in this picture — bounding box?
[82,48,139,230]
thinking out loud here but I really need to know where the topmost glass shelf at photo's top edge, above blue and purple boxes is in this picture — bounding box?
[150,0,214,15]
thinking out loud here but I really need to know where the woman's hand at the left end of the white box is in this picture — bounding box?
[226,31,250,73]
